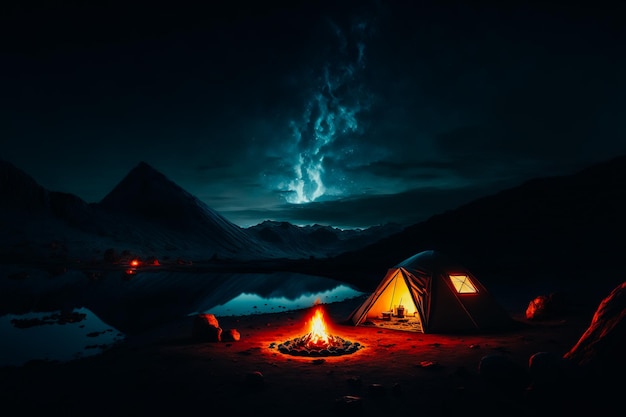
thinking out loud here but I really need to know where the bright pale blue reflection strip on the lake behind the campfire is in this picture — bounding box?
[194,285,361,316]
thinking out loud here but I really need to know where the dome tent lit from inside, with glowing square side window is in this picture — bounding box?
[348,250,512,333]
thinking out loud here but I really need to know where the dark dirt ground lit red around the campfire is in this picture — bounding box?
[0,292,608,417]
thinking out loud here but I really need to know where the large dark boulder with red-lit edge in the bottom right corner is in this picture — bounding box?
[528,282,626,416]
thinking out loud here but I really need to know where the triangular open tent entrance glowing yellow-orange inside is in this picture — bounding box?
[363,269,424,333]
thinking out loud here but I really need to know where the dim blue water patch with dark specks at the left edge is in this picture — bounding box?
[0,308,123,366]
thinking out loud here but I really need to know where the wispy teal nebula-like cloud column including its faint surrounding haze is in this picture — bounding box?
[251,8,378,204]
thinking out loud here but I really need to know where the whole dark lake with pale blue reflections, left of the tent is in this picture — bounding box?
[0,269,362,366]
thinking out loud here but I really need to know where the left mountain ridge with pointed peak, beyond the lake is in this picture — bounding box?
[0,160,399,260]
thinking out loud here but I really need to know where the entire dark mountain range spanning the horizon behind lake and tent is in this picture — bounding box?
[0,156,626,284]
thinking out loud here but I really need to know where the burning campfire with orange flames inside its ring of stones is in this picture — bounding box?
[278,305,363,356]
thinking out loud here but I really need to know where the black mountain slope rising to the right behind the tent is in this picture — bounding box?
[303,156,626,290]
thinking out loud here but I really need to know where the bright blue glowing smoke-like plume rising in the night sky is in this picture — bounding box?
[278,17,371,204]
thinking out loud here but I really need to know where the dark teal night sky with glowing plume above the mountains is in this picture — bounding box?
[0,0,626,227]
